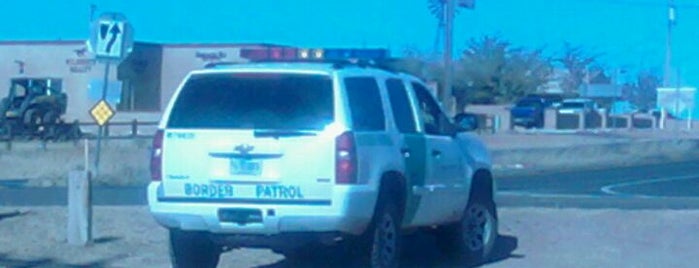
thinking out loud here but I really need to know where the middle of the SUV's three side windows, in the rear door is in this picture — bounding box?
[386,79,417,133]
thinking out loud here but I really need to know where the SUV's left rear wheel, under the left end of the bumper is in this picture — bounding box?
[170,229,223,268]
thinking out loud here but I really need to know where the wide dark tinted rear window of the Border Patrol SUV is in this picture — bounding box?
[168,73,334,130]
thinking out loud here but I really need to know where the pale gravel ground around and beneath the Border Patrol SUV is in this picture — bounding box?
[0,207,699,267]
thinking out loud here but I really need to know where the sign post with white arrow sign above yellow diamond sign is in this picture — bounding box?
[89,13,133,175]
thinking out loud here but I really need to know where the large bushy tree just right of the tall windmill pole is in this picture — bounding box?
[454,36,551,109]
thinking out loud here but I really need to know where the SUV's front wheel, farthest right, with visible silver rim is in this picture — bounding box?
[437,192,498,265]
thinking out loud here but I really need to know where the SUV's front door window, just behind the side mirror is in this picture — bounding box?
[412,82,454,135]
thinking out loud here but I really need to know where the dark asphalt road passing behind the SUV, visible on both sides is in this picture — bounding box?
[0,161,699,209]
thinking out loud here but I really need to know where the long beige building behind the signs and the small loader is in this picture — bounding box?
[0,41,282,125]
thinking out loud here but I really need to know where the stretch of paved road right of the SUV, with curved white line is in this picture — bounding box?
[498,162,699,209]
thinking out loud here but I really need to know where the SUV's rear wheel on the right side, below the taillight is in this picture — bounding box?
[368,199,402,268]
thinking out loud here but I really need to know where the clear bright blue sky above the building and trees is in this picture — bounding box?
[0,0,699,86]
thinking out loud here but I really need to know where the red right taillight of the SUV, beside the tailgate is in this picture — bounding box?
[335,132,357,184]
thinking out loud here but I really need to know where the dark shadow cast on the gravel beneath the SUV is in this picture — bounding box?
[259,233,524,268]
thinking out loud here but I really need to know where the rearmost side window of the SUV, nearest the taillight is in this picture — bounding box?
[345,77,386,131]
